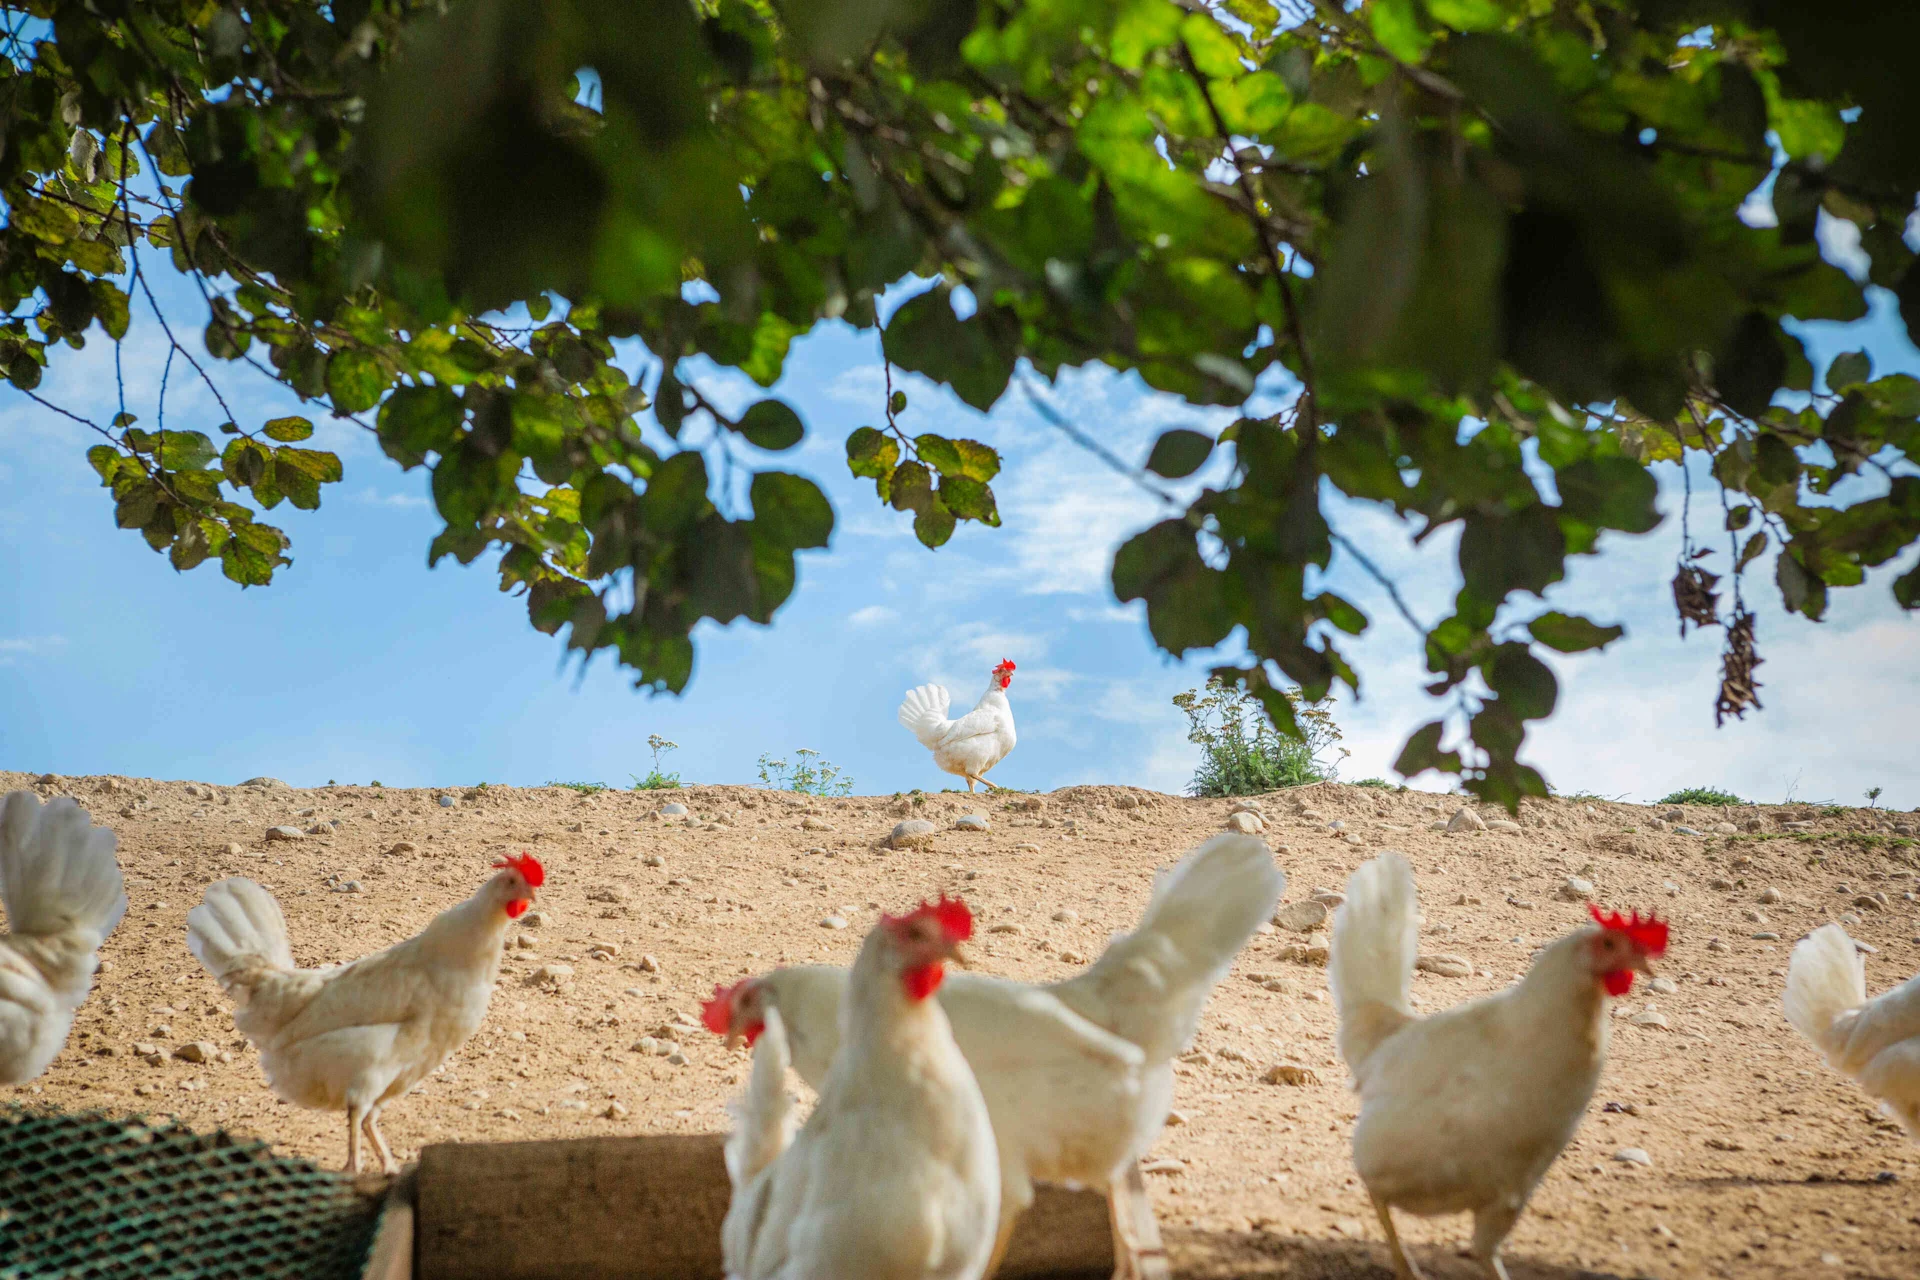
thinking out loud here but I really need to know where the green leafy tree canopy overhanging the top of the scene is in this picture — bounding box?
[0,0,1920,806]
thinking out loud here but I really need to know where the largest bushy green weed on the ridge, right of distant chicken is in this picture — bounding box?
[1173,676,1346,796]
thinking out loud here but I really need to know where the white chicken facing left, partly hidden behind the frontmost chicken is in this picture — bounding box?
[705,835,1286,1259]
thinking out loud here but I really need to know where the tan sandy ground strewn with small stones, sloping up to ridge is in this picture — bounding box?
[0,771,1920,1280]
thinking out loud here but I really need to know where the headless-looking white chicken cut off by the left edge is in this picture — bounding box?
[0,791,127,1084]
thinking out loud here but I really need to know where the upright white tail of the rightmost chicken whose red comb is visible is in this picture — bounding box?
[1327,852,1421,1071]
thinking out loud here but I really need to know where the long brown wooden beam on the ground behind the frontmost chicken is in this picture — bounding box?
[415,1134,1121,1280]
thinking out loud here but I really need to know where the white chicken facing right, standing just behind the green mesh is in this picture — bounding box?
[186,854,547,1173]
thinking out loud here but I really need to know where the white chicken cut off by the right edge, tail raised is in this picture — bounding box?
[1786,925,1920,1140]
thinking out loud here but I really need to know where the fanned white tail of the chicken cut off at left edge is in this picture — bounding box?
[0,791,127,946]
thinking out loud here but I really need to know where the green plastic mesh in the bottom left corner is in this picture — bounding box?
[0,1107,382,1280]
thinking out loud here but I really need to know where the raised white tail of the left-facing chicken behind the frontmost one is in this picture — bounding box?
[1075,833,1286,1065]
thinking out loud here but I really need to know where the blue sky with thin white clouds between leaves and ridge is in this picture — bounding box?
[0,213,1920,808]
